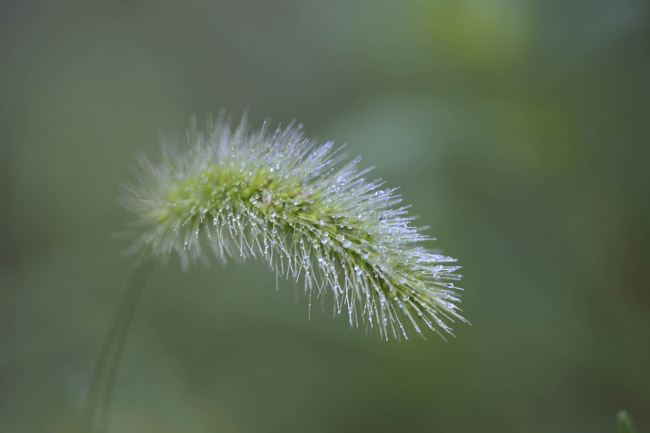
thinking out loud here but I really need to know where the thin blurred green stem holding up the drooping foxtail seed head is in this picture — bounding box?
[82,259,153,433]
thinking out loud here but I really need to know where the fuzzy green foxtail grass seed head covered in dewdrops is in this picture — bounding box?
[123,117,465,339]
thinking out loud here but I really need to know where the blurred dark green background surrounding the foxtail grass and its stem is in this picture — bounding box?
[0,0,650,433]
